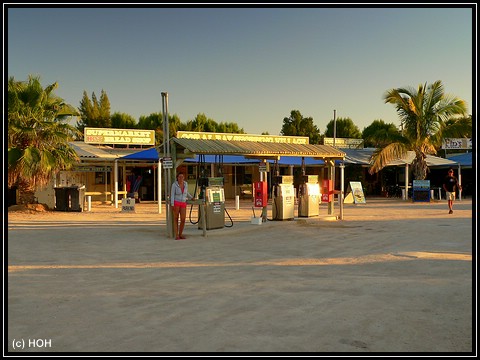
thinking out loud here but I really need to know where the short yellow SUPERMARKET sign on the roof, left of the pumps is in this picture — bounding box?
[83,127,155,145]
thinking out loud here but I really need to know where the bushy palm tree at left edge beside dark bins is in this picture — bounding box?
[8,75,78,204]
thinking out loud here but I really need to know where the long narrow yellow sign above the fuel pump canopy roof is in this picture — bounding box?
[177,131,308,145]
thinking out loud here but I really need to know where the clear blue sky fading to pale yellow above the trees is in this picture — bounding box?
[4,4,476,135]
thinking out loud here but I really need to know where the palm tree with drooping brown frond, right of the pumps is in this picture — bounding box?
[369,80,467,180]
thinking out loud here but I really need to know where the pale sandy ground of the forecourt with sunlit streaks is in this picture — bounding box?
[4,198,476,356]
